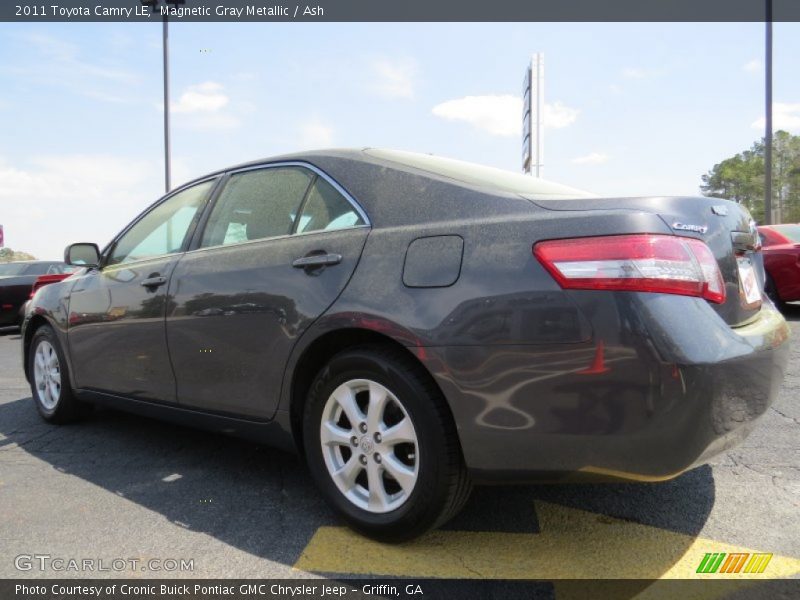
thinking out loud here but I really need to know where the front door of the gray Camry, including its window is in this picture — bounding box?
[67,181,214,402]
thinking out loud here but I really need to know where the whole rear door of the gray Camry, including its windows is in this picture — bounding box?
[167,163,369,419]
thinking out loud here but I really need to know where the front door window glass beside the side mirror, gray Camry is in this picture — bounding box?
[108,181,214,265]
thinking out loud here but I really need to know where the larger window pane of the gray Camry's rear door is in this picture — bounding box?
[200,167,313,247]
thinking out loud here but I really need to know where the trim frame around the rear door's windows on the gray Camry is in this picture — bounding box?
[184,160,372,253]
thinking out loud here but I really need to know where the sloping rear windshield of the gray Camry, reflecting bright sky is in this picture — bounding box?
[365,148,596,200]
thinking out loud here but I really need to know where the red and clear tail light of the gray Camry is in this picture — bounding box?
[533,234,725,304]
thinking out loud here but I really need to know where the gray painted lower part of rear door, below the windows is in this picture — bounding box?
[166,228,369,419]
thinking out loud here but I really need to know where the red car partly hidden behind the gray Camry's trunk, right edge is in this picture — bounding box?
[758,223,800,304]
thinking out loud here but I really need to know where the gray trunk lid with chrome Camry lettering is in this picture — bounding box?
[526,196,764,326]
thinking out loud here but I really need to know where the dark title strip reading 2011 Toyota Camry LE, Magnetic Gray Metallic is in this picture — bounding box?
[0,0,800,22]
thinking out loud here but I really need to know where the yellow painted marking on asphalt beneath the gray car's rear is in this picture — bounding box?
[294,502,800,580]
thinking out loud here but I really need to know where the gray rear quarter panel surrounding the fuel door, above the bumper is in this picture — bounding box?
[315,208,669,347]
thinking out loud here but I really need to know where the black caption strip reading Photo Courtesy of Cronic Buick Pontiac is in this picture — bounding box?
[0,577,800,600]
